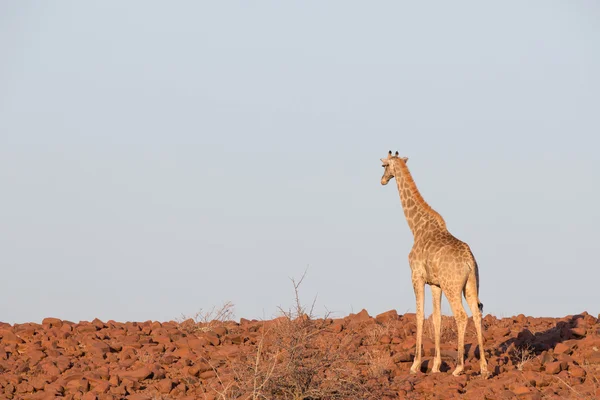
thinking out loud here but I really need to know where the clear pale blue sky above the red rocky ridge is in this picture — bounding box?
[0,1,600,323]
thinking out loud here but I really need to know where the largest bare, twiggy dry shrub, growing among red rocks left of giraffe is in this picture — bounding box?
[206,273,379,400]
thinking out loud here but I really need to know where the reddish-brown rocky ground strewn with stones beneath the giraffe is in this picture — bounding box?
[0,310,600,400]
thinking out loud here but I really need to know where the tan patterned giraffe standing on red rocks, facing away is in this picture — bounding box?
[381,151,489,378]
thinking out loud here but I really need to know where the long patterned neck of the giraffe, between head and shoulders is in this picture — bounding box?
[394,162,446,238]
